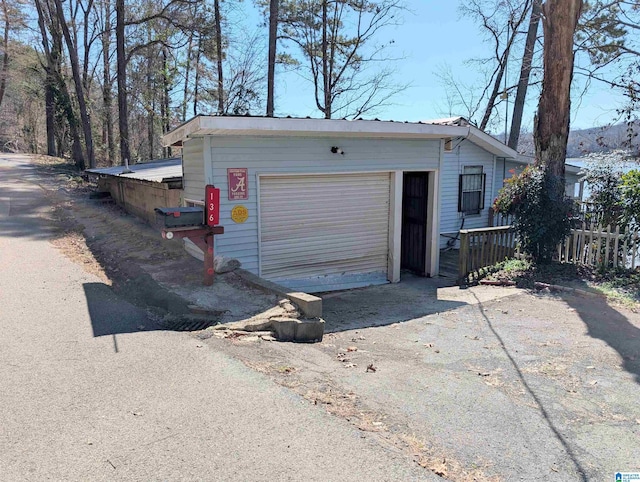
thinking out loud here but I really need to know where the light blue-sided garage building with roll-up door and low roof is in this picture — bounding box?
[163,116,517,292]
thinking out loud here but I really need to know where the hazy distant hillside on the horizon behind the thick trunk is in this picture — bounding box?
[502,122,640,157]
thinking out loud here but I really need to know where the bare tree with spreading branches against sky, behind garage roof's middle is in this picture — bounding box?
[279,0,406,119]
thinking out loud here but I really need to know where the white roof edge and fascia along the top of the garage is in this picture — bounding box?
[162,116,517,158]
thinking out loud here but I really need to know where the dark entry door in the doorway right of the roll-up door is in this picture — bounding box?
[400,172,429,276]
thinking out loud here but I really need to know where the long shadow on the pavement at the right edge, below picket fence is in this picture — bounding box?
[563,296,640,384]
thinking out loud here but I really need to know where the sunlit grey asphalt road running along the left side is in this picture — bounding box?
[0,155,438,481]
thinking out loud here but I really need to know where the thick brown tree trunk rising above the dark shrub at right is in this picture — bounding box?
[534,0,583,178]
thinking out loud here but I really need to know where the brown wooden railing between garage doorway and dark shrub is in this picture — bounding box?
[458,226,516,281]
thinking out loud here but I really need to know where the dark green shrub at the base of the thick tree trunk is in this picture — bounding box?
[493,166,576,263]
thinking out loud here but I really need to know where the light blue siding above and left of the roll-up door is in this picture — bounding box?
[208,137,442,273]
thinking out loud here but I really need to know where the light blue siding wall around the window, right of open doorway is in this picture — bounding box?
[440,140,494,248]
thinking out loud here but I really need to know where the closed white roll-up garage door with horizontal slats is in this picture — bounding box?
[260,173,390,292]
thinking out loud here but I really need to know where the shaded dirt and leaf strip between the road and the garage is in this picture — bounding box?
[31,158,278,322]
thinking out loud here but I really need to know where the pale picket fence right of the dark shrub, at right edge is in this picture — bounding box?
[557,223,640,269]
